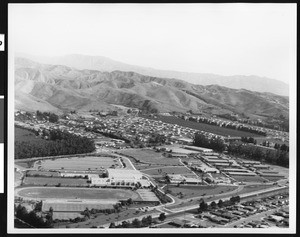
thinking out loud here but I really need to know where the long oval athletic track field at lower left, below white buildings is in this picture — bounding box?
[15,187,141,200]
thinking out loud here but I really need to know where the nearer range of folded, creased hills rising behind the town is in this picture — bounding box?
[15,58,288,116]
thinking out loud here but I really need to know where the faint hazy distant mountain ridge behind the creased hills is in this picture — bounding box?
[15,54,289,96]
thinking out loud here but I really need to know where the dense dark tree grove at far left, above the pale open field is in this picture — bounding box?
[15,130,95,159]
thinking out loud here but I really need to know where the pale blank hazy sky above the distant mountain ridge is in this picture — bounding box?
[9,4,296,83]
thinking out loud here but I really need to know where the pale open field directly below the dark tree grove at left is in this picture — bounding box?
[40,156,122,171]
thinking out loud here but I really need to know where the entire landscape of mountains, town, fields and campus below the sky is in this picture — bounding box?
[9,3,296,232]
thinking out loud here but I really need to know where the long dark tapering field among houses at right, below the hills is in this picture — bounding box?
[145,116,261,137]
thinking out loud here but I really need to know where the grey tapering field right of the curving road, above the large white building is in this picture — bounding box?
[120,149,182,166]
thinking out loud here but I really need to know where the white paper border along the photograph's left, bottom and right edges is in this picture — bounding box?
[7,3,296,234]
